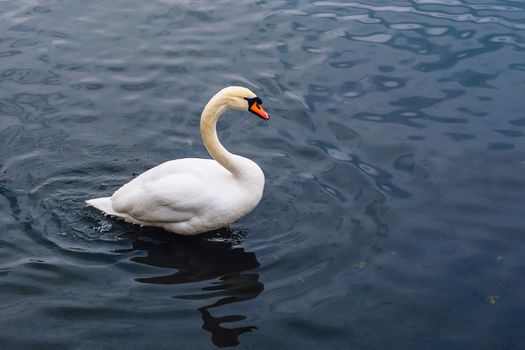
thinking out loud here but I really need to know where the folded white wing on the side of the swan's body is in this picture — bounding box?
[111,174,214,222]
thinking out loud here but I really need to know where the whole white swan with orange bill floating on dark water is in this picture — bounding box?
[86,86,270,235]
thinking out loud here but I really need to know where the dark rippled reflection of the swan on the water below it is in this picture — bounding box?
[121,229,264,347]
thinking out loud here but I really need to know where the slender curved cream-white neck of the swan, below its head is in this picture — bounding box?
[200,95,241,175]
